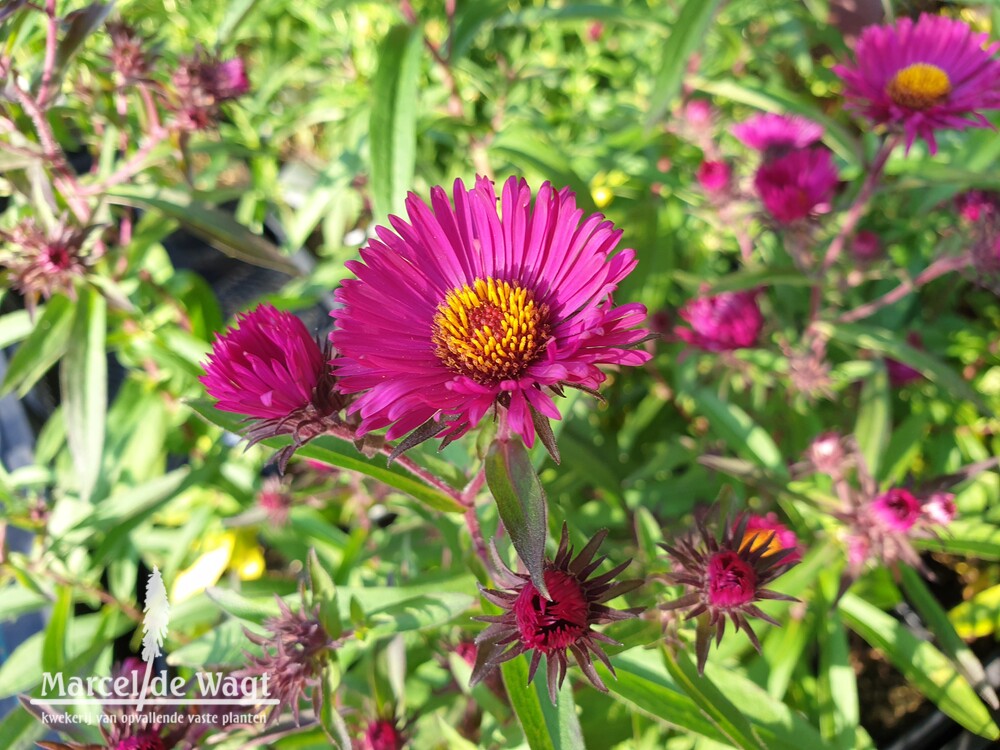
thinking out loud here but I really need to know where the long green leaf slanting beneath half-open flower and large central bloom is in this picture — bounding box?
[187,399,465,513]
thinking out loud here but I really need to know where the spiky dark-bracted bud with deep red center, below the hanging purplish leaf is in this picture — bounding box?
[471,524,643,703]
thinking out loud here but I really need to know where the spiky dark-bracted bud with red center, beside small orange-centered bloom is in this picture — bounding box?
[660,514,798,674]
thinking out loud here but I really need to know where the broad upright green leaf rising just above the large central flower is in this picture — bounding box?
[370,24,423,220]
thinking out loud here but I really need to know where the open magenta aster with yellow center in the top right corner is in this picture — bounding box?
[833,13,1000,154]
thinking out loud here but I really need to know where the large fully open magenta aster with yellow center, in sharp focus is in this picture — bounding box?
[331,177,650,446]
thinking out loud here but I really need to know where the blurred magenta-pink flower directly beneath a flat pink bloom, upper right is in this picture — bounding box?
[754,148,840,224]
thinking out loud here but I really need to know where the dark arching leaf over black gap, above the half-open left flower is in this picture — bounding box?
[105,185,302,276]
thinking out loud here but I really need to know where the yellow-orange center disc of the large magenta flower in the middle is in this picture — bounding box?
[432,277,549,385]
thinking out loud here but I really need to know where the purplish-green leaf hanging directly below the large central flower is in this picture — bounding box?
[485,437,549,598]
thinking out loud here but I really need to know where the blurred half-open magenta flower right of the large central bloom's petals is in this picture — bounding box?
[674,292,764,352]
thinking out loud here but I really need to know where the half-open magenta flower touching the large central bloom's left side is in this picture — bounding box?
[201,305,346,471]
